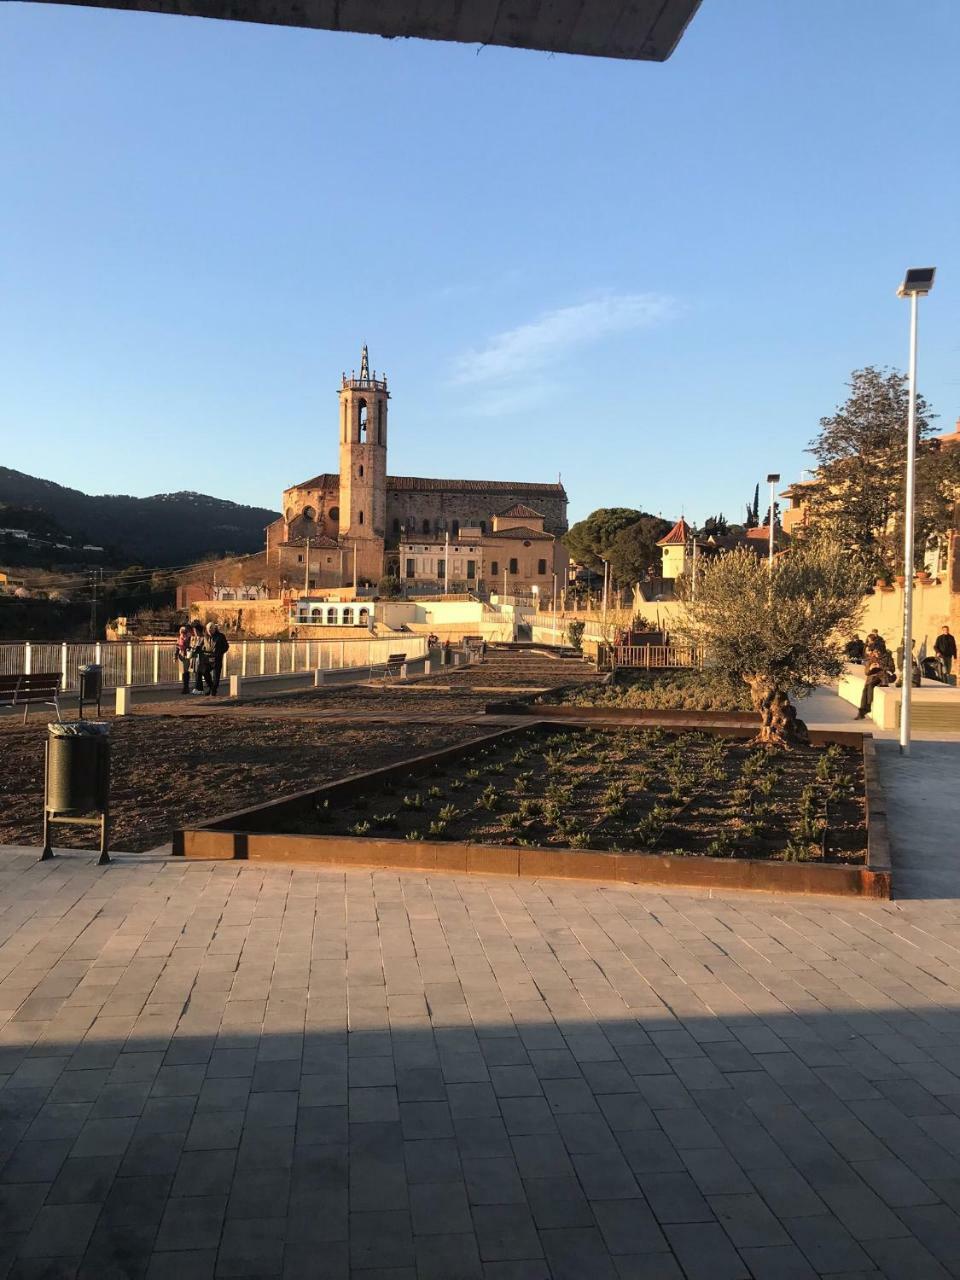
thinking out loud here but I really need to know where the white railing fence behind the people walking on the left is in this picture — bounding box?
[0,635,428,690]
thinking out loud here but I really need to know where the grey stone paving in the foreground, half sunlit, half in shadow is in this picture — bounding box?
[0,849,960,1280]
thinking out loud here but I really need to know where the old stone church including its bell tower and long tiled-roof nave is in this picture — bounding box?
[266,347,567,586]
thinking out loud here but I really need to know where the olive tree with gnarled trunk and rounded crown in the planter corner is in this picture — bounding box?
[678,543,867,746]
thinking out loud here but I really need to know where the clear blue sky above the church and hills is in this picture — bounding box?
[0,0,960,521]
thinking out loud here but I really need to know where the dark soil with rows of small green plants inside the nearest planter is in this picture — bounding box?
[284,730,867,863]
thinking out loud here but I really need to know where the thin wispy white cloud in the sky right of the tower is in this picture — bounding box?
[453,293,678,385]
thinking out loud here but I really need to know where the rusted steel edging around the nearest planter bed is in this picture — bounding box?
[173,719,892,899]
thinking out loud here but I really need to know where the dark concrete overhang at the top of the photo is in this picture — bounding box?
[30,0,700,63]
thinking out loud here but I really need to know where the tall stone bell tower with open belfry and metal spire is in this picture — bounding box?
[338,346,390,582]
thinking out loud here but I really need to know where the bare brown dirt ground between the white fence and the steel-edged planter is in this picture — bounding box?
[0,653,595,851]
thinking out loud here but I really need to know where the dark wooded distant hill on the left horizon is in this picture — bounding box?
[0,467,278,566]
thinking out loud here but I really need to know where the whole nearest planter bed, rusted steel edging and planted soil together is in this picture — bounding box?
[174,727,890,897]
